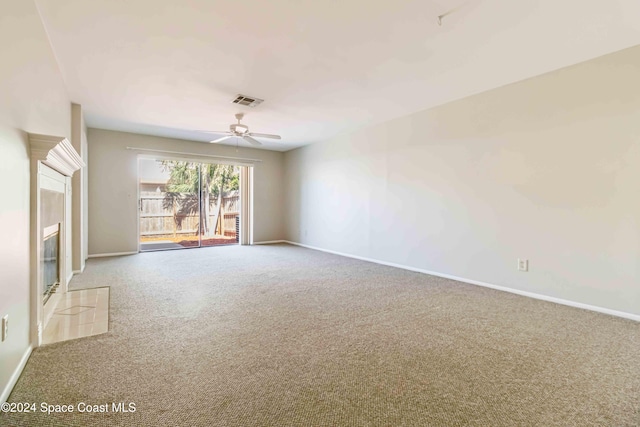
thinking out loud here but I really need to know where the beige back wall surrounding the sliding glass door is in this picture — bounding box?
[88,128,284,256]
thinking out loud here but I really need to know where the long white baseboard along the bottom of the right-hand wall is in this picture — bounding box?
[284,240,640,322]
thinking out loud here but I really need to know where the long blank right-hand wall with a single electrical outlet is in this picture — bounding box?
[285,47,640,315]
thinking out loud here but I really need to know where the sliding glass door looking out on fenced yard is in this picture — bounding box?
[139,158,240,251]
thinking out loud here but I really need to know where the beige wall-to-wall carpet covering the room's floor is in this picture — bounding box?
[0,245,640,426]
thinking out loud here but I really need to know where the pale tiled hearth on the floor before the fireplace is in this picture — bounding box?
[42,288,109,344]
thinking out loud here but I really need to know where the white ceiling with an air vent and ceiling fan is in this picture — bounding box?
[36,0,640,151]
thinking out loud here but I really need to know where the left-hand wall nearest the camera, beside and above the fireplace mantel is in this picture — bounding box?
[0,0,71,400]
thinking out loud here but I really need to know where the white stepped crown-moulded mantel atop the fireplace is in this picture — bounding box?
[29,133,85,176]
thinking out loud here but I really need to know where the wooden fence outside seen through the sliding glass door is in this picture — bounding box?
[140,191,240,237]
